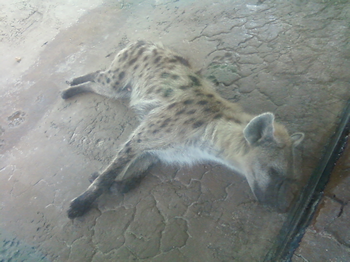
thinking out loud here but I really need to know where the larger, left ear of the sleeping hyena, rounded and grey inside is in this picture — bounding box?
[243,113,275,145]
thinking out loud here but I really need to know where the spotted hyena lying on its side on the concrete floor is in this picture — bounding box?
[62,41,304,218]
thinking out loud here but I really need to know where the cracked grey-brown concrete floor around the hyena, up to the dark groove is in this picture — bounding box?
[0,0,350,261]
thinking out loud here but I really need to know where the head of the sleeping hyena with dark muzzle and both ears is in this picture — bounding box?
[243,113,304,212]
